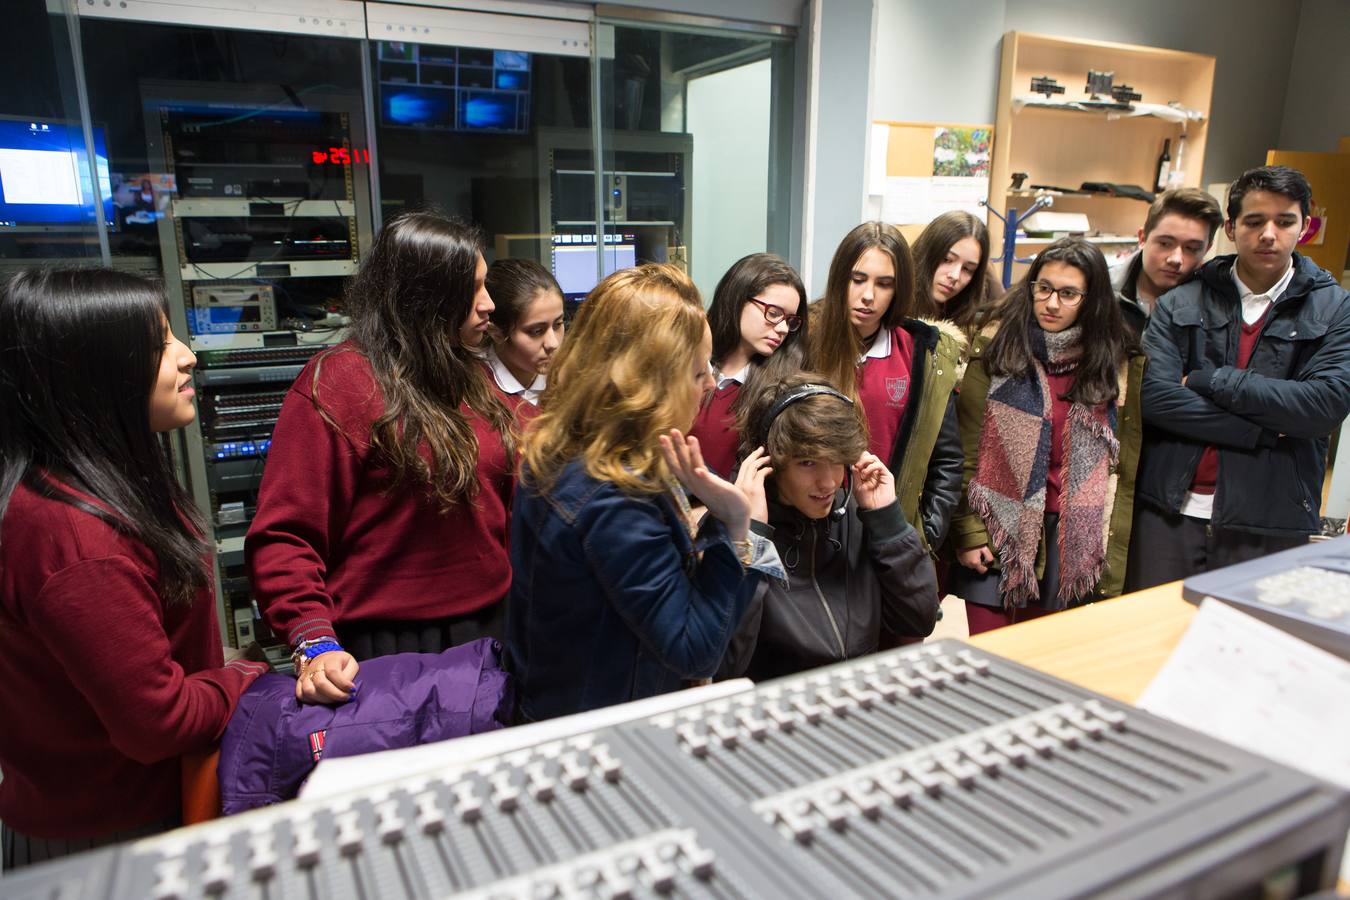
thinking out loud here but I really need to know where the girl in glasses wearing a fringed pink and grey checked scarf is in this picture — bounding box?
[948,237,1143,634]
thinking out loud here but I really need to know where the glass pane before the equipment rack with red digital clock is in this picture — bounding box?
[73,18,373,663]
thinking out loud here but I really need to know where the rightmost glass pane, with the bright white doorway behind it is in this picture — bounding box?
[597,20,792,302]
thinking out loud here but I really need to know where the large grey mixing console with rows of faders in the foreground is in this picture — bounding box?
[0,641,1350,900]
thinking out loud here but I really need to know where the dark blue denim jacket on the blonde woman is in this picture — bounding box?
[506,460,759,721]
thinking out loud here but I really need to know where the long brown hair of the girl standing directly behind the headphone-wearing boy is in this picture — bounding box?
[810,221,914,398]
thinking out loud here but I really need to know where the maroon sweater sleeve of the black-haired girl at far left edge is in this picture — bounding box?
[27,556,267,765]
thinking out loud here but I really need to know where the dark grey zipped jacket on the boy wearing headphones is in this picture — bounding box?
[720,498,938,681]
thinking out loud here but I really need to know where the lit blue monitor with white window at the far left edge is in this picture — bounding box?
[0,116,116,233]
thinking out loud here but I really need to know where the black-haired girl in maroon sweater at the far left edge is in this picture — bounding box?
[0,269,269,863]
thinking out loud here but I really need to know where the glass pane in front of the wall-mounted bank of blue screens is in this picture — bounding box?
[370,12,595,315]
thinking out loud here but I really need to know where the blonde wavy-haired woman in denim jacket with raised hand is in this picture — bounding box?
[506,263,778,722]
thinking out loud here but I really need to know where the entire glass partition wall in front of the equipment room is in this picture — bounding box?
[44,0,794,658]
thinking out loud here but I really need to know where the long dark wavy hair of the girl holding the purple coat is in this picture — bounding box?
[332,210,514,509]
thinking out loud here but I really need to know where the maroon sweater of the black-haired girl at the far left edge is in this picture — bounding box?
[0,486,267,838]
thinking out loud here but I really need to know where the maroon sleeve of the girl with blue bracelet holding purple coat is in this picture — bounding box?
[244,368,373,645]
